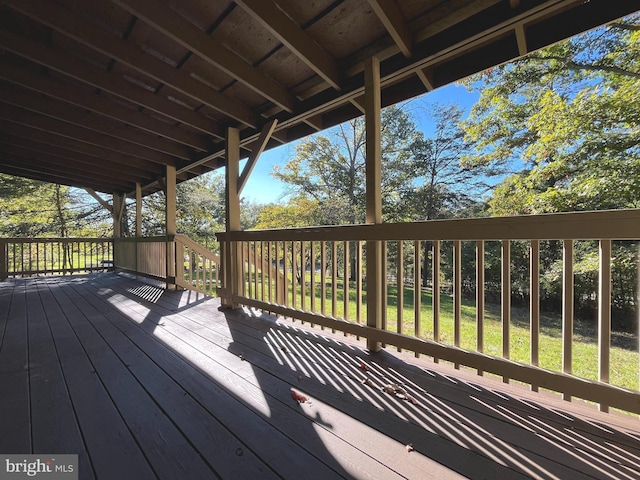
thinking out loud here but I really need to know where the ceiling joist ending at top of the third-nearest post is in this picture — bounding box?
[0,105,176,165]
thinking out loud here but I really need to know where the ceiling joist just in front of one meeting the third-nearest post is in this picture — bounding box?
[0,90,191,159]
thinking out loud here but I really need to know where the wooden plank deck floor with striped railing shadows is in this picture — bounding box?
[0,274,640,480]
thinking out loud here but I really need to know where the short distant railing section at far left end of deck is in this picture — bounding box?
[0,238,113,279]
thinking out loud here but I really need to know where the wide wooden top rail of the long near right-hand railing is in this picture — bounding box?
[216,209,640,241]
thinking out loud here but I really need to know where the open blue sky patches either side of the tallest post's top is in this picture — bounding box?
[240,84,478,204]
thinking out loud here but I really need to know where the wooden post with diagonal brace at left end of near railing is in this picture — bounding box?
[223,127,242,307]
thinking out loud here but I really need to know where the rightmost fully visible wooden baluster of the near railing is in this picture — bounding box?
[598,240,611,412]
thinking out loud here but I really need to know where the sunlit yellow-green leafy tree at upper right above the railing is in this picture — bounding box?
[464,15,640,214]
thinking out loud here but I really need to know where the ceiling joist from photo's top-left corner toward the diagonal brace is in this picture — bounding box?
[7,0,257,128]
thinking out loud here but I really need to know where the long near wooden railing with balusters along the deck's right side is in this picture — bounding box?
[218,210,640,413]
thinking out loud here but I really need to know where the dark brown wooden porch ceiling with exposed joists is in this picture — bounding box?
[0,0,639,194]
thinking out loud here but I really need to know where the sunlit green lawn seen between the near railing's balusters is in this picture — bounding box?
[244,274,639,389]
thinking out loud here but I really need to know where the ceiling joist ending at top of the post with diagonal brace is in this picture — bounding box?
[0,30,223,139]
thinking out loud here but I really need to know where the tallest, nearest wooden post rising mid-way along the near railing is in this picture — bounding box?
[364,57,384,352]
